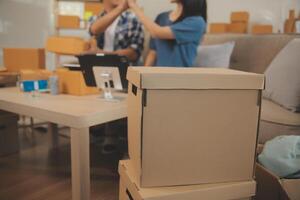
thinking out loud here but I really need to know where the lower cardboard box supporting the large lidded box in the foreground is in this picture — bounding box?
[119,161,256,200]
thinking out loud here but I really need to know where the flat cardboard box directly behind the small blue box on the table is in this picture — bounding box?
[20,70,53,81]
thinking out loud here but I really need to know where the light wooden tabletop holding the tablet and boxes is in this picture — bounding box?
[0,88,127,128]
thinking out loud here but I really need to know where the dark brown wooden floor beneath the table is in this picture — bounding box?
[0,126,124,200]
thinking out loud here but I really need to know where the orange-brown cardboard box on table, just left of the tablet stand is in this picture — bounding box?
[56,69,99,96]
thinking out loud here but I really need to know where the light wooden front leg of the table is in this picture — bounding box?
[71,128,91,200]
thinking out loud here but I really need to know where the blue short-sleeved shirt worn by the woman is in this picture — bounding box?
[150,12,206,67]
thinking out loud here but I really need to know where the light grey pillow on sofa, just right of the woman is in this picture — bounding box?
[194,42,235,68]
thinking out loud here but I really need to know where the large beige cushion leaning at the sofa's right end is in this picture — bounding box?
[264,38,300,111]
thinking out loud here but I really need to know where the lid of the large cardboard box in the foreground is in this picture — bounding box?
[127,67,264,90]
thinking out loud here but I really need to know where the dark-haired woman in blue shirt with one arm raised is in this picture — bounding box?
[128,0,206,67]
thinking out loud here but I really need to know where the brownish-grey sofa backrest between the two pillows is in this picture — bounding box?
[202,34,300,73]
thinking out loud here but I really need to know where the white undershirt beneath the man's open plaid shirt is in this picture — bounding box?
[103,17,120,51]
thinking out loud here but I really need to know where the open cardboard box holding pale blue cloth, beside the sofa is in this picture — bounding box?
[255,164,300,200]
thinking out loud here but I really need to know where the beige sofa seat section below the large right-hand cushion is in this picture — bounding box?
[261,99,300,126]
